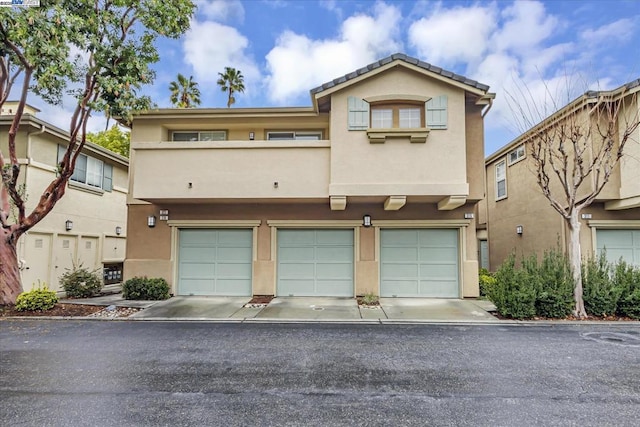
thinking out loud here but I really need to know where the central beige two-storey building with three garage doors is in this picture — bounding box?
[125,54,493,298]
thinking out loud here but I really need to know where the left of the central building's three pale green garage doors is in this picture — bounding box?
[178,229,253,296]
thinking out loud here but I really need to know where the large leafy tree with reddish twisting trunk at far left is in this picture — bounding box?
[0,0,195,304]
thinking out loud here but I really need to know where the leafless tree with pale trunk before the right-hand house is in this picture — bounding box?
[508,79,640,317]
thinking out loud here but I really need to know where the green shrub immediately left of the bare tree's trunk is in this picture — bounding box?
[530,249,575,318]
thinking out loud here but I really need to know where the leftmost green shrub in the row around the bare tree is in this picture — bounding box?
[489,254,536,319]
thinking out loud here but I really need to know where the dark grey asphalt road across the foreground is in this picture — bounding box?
[0,319,640,427]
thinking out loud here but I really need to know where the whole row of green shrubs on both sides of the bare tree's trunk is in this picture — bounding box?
[487,249,640,319]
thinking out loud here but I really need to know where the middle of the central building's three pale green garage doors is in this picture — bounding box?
[277,229,353,297]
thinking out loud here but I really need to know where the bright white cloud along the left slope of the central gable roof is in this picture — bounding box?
[266,2,401,103]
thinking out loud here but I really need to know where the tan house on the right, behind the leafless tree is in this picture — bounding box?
[478,80,640,270]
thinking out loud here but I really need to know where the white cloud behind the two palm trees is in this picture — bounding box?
[181,21,260,106]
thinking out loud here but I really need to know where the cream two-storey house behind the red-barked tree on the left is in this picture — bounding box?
[0,102,129,291]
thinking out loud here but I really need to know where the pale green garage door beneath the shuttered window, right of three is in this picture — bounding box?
[380,229,460,298]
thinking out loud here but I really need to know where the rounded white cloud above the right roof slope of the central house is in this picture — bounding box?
[409,6,496,67]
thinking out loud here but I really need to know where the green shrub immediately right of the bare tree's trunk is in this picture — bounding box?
[582,253,624,316]
